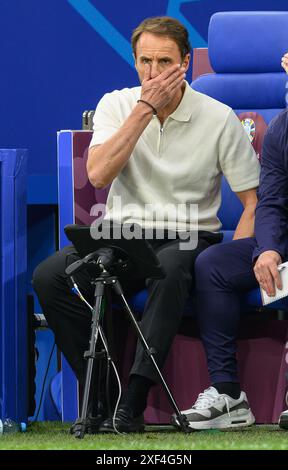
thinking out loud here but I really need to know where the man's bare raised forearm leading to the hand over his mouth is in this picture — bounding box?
[87,103,153,188]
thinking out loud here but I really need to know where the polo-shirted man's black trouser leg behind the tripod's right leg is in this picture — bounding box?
[131,233,220,382]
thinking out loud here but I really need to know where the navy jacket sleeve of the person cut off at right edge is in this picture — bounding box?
[253,109,288,261]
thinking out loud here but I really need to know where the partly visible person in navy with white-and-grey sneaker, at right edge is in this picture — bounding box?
[173,54,288,429]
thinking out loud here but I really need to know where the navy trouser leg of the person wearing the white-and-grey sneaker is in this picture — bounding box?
[195,238,258,384]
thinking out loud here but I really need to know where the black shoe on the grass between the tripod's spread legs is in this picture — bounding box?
[99,405,145,433]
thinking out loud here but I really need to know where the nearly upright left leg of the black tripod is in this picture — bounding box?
[74,282,104,439]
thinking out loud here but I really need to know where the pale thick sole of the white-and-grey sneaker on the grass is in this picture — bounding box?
[172,410,255,431]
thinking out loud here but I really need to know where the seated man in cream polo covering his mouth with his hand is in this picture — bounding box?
[33,17,260,432]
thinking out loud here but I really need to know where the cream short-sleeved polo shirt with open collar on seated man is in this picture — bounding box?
[90,82,260,232]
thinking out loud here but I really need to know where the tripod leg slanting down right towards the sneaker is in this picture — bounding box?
[113,280,191,433]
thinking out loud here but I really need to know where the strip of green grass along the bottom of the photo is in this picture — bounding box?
[0,422,288,450]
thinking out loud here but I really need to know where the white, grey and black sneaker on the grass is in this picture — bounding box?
[172,387,255,430]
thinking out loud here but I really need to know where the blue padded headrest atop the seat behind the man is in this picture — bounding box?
[208,11,288,73]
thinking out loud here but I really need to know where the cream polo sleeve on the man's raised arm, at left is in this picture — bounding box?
[90,93,122,147]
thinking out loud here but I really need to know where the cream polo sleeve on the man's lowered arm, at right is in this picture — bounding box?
[219,110,260,192]
